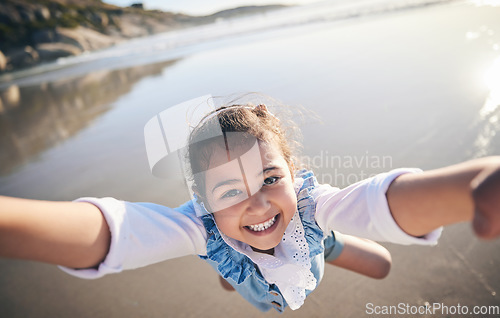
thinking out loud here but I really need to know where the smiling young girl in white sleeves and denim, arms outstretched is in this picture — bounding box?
[0,98,500,311]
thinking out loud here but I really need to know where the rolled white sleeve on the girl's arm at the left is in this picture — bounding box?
[60,198,207,279]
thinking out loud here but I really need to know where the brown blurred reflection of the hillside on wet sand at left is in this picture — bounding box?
[0,60,180,174]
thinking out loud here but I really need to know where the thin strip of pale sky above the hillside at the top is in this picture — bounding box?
[103,0,318,15]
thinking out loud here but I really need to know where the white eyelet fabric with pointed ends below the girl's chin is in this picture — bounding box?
[219,211,317,310]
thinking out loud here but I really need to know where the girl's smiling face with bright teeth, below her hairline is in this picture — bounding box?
[205,141,297,251]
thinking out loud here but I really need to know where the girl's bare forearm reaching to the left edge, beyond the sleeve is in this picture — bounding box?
[0,196,111,268]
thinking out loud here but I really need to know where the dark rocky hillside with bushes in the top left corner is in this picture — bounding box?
[0,0,282,72]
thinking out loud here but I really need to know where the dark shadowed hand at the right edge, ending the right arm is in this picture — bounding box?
[471,166,500,239]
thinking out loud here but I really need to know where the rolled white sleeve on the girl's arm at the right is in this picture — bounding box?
[313,169,442,245]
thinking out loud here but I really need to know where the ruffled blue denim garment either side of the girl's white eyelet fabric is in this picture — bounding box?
[200,170,324,312]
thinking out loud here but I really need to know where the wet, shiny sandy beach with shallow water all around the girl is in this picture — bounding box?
[0,1,500,318]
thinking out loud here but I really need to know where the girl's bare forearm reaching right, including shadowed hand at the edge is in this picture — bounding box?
[386,157,500,238]
